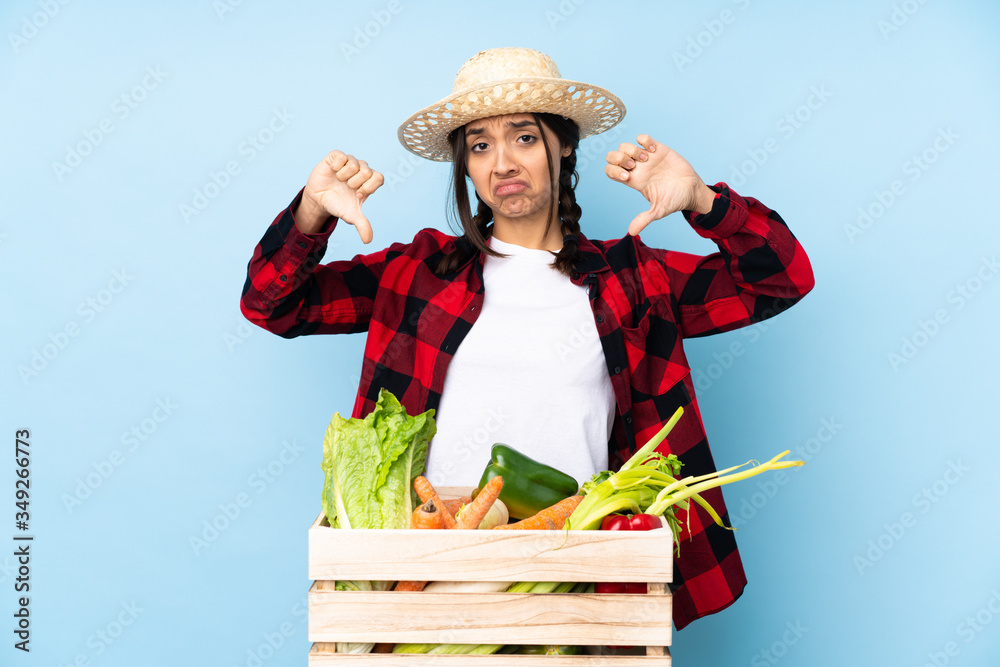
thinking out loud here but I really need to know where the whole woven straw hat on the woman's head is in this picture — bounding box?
[397,48,625,162]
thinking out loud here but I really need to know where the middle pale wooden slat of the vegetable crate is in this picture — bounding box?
[309,587,672,646]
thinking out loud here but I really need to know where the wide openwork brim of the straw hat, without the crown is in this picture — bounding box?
[396,77,625,162]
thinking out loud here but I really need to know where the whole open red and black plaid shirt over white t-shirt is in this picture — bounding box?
[241,183,813,629]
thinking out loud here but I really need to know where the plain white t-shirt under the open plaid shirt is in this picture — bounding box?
[426,238,615,486]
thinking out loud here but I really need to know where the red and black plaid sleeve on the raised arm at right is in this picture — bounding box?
[660,183,813,338]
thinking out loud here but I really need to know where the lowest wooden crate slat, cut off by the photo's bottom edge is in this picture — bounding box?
[309,643,671,667]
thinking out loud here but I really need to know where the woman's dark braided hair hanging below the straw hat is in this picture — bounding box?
[434,113,583,276]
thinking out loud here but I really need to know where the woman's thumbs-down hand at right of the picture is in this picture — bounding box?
[604,134,715,236]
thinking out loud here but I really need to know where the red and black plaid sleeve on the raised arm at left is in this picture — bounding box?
[240,191,398,338]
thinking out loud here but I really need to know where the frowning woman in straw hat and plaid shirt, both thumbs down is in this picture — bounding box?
[241,49,813,629]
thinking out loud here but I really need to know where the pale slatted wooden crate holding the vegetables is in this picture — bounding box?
[309,487,673,667]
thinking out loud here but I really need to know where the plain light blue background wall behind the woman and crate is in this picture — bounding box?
[0,0,1000,667]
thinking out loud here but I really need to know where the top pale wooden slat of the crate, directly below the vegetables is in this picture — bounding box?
[309,516,673,582]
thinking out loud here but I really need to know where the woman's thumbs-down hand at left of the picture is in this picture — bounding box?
[295,151,385,243]
